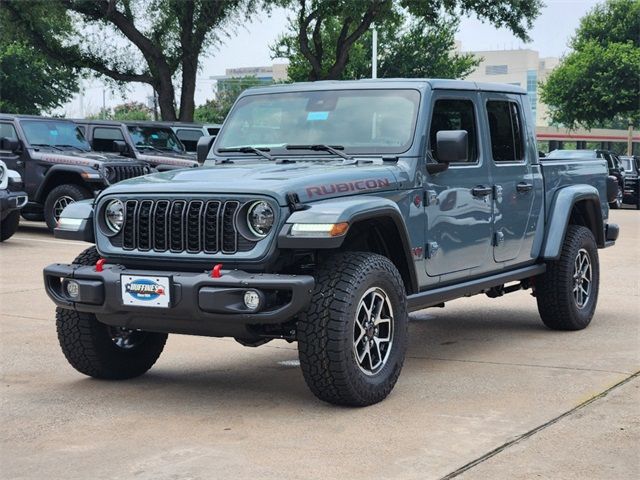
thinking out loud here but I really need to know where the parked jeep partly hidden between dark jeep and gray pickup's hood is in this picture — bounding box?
[75,120,199,172]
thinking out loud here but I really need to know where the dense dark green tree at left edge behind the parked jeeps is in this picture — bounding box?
[0,41,79,115]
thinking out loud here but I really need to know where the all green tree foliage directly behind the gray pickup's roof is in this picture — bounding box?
[272,0,542,80]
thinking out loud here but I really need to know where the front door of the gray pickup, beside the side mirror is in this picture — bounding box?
[425,91,493,280]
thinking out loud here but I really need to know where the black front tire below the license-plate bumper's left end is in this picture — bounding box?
[56,247,167,380]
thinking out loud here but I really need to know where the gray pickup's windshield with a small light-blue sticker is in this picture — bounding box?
[216,90,420,154]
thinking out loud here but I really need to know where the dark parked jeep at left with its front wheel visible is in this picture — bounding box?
[0,114,152,230]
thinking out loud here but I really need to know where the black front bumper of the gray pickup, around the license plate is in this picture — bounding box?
[44,263,314,336]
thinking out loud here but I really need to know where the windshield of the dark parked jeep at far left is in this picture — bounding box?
[20,120,91,151]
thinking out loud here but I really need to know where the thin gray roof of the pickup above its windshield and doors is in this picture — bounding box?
[245,78,527,95]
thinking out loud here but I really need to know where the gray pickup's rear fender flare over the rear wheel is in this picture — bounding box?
[542,185,605,260]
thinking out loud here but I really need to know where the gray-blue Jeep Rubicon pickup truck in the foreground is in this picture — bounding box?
[44,80,618,406]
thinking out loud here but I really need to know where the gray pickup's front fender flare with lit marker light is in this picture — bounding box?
[278,195,418,291]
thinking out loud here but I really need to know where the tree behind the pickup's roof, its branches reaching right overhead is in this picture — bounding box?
[274,0,542,80]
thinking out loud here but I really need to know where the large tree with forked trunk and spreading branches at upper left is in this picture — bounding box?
[1,0,256,121]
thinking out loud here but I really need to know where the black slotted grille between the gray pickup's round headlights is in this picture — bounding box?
[122,200,256,253]
